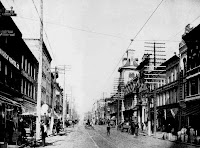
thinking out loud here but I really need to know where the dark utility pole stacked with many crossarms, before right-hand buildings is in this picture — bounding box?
[145,42,166,135]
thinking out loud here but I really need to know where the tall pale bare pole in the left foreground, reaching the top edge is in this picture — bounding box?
[36,0,43,139]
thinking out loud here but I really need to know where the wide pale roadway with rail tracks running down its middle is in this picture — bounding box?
[36,125,197,148]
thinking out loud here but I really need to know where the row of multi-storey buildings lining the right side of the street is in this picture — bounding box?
[90,24,200,144]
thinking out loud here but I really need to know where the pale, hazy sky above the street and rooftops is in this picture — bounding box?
[1,0,200,115]
